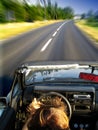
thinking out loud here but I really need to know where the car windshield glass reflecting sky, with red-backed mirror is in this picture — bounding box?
[25,64,98,85]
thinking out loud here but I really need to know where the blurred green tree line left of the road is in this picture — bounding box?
[0,0,74,23]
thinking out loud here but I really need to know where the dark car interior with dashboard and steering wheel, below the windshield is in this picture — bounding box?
[0,64,98,130]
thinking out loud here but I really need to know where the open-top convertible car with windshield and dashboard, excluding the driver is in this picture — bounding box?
[0,62,98,130]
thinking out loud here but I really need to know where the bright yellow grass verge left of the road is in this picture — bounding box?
[0,20,60,40]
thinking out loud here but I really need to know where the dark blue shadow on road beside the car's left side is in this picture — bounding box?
[0,75,13,96]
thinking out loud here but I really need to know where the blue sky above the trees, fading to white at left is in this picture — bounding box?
[29,0,98,14]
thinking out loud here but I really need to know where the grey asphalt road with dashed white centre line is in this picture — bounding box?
[0,21,98,95]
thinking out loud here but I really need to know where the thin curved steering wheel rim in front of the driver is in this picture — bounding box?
[39,92,72,119]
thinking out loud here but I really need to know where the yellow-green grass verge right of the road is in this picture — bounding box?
[76,20,98,42]
